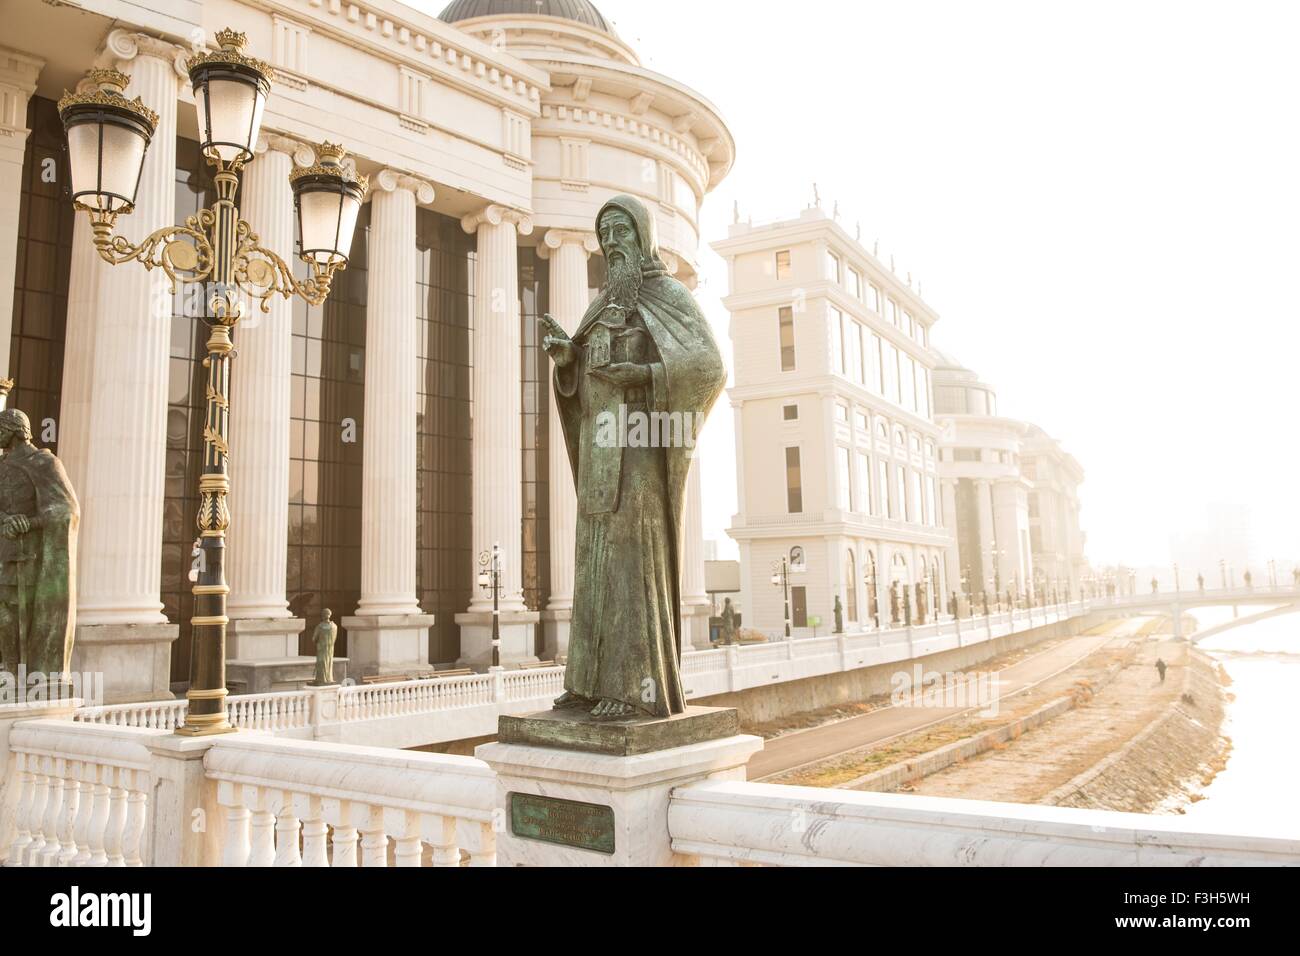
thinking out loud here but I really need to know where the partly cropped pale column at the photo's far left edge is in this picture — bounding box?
[0,47,46,378]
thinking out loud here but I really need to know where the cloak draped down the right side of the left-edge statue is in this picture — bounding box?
[0,449,81,675]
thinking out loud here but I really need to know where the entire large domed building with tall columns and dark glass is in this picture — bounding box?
[0,0,735,700]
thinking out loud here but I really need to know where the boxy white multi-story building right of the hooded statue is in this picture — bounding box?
[712,208,953,635]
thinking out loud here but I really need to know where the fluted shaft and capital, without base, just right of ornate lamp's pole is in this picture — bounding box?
[226,134,312,619]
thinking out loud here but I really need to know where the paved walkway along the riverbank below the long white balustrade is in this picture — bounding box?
[748,618,1145,780]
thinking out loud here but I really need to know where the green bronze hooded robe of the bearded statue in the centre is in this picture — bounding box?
[554,196,727,717]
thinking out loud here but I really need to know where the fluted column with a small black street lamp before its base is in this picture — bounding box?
[456,206,540,667]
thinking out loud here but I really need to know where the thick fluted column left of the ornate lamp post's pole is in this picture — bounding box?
[69,30,185,702]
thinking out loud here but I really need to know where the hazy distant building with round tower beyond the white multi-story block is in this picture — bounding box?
[935,352,1087,610]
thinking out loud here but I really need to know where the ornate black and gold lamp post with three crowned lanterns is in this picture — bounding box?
[59,30,369,736]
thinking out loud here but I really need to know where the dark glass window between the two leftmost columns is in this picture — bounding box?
[9,96,74,439]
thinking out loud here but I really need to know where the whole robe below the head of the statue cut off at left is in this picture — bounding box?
[0,444,81,675]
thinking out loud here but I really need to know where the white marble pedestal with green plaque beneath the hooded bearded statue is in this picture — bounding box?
[475,708,763,866]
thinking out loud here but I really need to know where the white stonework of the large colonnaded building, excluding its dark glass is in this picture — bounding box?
[0,0,735,700]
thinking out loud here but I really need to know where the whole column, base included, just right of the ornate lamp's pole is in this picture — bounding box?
[226,134,316,693]
